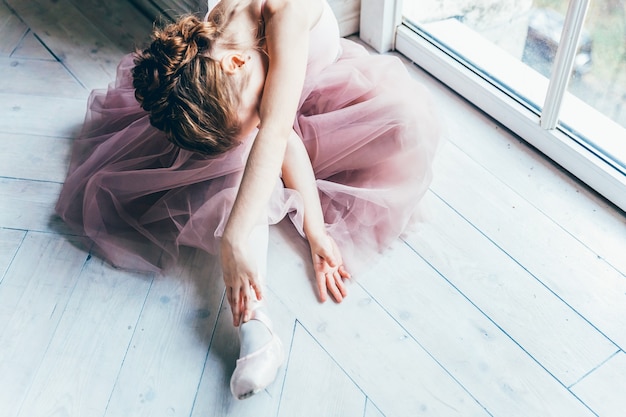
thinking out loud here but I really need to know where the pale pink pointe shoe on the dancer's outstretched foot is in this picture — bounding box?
[230,310,285,400]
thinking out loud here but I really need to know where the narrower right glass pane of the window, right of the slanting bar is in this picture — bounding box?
[556,0,626,173]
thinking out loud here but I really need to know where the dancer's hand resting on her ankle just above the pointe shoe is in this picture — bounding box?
[220,238,263,327]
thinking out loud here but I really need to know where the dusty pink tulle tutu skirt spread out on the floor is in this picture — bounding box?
[56,40,439,271]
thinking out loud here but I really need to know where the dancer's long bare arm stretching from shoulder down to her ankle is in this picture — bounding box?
[220,0,321,326]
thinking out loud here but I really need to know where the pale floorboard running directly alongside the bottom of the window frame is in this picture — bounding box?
[416,66,626,274]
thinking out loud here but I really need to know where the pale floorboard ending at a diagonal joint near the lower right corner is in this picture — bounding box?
[404,189,618,386]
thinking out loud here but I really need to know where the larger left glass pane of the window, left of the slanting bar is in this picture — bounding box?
[403,0,567,109]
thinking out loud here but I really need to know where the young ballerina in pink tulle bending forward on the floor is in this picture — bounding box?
[57,0,438,398]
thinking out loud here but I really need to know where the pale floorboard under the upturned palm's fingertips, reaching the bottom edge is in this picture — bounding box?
[268,224,487,416]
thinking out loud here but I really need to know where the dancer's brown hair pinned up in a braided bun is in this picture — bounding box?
[132,11,247,155]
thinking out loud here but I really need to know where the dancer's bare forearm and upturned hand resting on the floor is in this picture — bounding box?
[283,132,350,302]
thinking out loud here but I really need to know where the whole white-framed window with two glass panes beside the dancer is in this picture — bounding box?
[361,0,626,210]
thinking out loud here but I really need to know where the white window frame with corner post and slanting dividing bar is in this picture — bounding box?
[360,0,626,211]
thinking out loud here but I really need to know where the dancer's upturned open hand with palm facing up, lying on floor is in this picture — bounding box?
[309,234,350,303]
